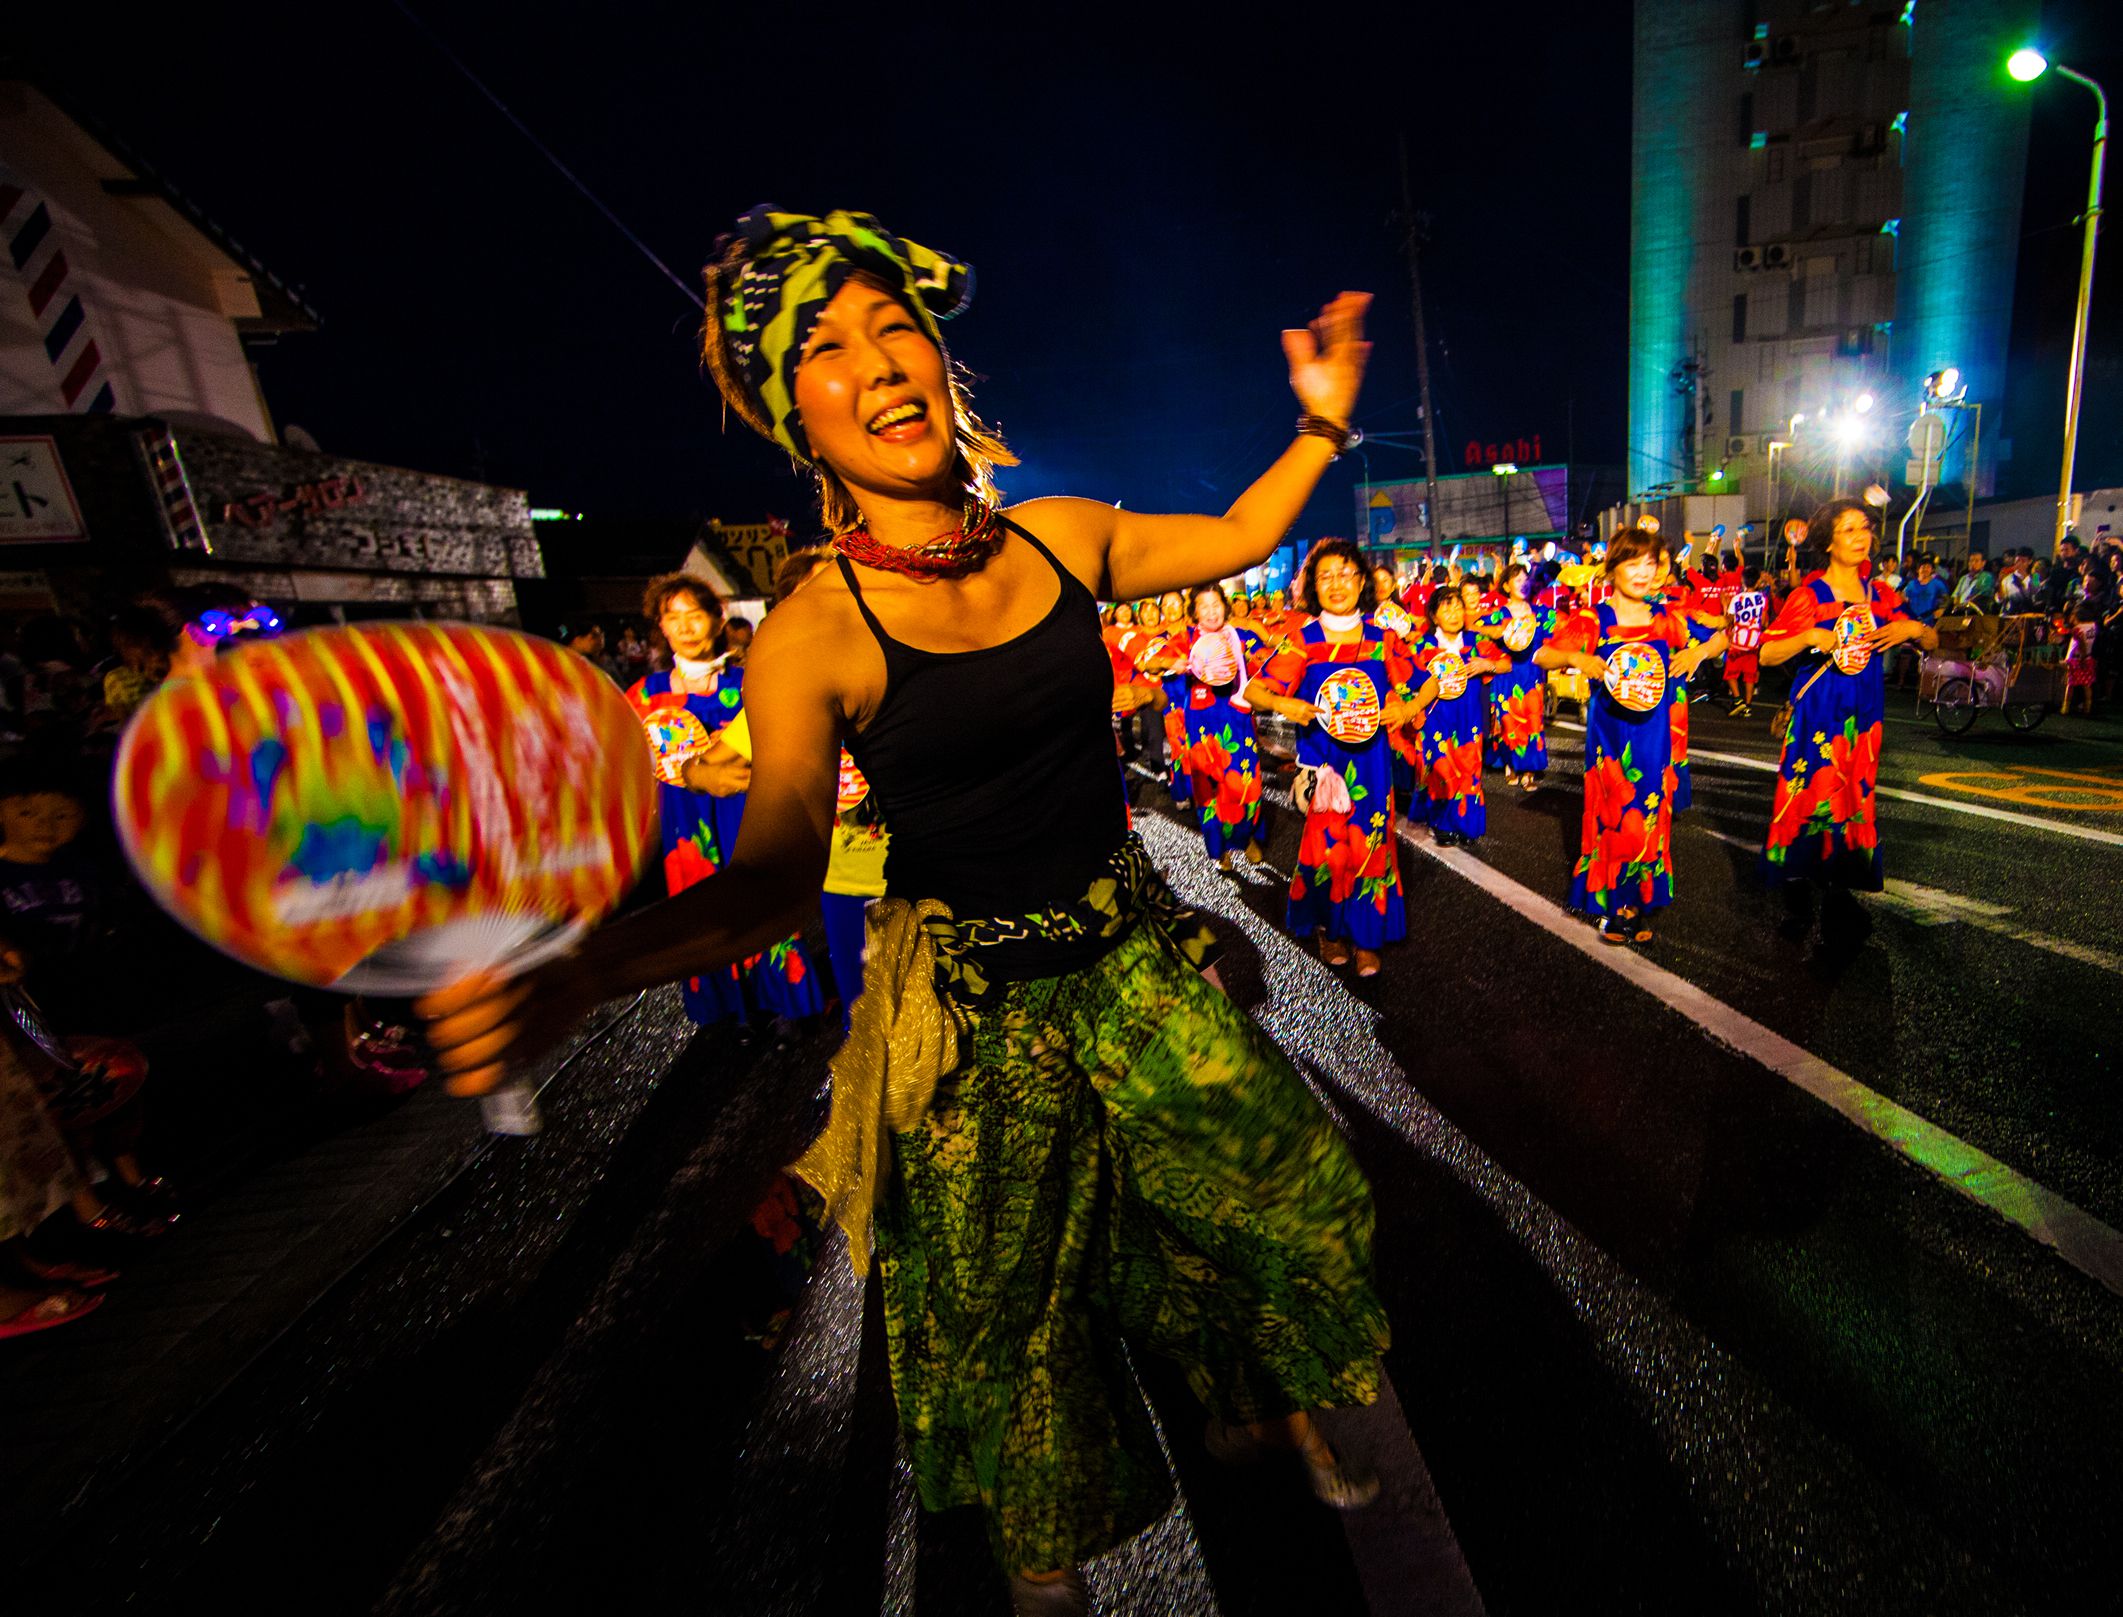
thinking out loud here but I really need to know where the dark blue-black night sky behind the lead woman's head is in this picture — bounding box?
[28,0,2123,537]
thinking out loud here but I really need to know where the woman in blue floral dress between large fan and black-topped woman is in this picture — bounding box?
[626,573,826,1023]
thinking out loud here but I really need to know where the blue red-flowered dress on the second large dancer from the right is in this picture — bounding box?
[1550,605,1690,917]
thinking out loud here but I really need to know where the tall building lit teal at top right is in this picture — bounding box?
[1628,0,2038,520]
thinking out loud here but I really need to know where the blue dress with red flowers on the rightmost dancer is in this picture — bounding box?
[1762,573,1909,893]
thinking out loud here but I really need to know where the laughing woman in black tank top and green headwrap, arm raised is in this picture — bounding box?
[425,208,1386,1611]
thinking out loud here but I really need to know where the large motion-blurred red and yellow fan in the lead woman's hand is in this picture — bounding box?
[113,624,656,995]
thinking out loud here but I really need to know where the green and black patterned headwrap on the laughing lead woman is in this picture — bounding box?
[720,204,972,460]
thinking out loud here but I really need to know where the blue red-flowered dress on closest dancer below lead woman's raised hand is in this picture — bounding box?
[1261,618,1414,949]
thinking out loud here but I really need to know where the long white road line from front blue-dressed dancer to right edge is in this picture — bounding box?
[1401,825,2123,1294]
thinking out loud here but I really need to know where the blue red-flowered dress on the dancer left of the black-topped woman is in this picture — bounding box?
[626,668,826,1025]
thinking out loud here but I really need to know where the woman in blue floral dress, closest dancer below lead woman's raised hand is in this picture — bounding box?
[1246,539,1414,976]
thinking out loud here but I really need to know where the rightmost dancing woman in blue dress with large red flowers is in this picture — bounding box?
[1762,499,1938,929]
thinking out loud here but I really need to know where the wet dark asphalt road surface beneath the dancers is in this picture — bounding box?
[23,674,2123,1617]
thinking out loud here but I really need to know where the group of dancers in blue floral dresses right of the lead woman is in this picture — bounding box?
[1106,501,1936,959]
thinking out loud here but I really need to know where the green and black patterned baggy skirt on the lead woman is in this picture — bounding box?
[877,923,1386,1572]
